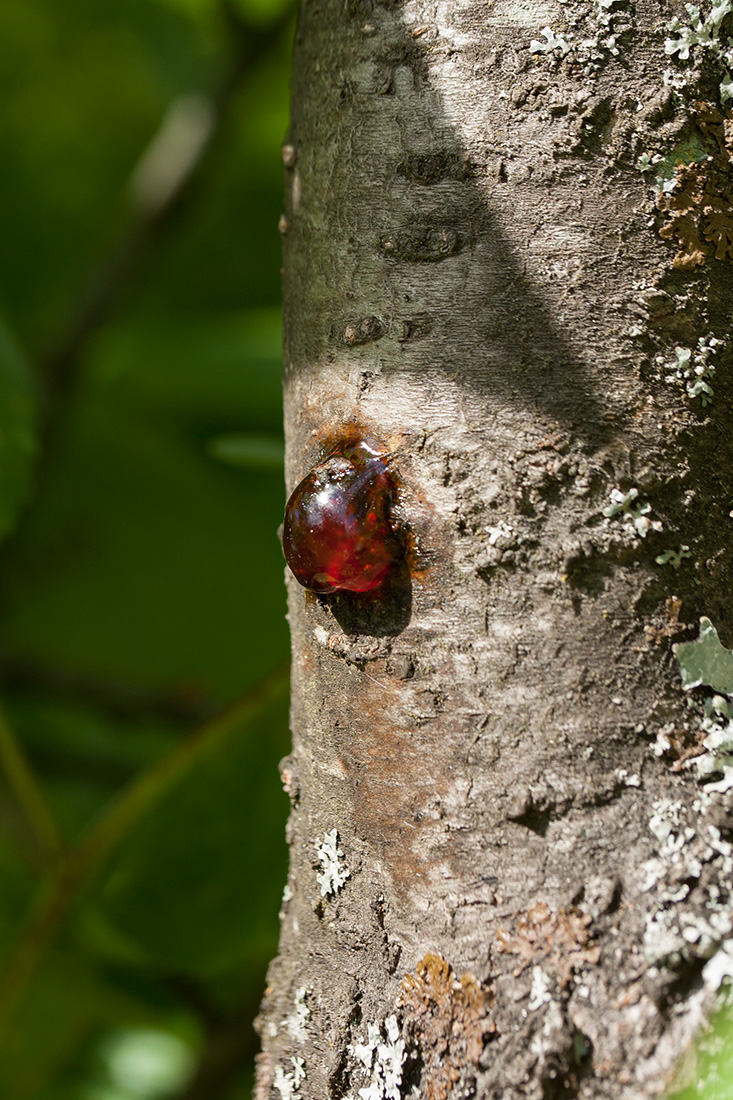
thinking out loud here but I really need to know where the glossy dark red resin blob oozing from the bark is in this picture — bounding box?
[283,443,403,593]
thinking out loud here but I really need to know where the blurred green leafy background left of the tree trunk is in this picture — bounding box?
[0,0,294,1100]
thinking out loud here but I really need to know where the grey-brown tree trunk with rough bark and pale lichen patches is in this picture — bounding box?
[255,0,733,1100]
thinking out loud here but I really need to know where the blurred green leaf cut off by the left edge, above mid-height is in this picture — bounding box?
[0,321,35,538]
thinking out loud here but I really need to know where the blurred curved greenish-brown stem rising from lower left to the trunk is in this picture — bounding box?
[0,668,288,1051]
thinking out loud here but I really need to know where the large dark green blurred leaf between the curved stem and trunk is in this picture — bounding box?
[100,706,286,977]
